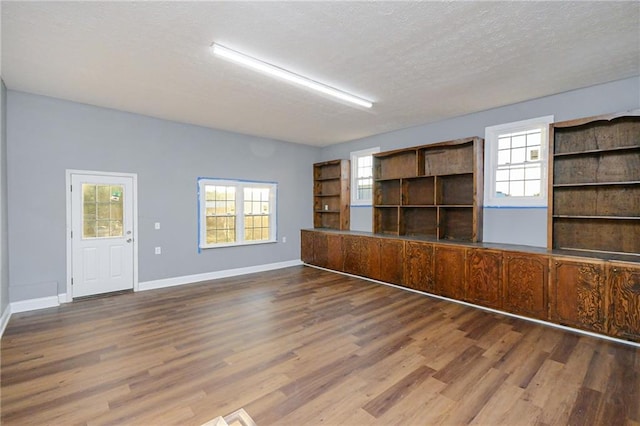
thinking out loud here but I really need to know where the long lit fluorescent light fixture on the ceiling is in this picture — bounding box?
[211,43,373,108]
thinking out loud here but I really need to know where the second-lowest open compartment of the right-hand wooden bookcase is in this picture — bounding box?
[553,183,640,217]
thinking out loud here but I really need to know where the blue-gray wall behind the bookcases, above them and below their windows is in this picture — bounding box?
[322,76,640,247]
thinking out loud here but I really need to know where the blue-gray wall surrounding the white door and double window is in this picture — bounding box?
[7,90,320,302]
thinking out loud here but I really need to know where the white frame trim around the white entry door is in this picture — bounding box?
[65,169,138,303]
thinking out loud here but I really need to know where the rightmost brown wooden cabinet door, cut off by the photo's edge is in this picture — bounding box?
[607,263,640,341]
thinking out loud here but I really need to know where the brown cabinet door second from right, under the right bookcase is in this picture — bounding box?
[549,258,605,333]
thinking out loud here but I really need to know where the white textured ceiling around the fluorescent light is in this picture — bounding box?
[1,1,640,146]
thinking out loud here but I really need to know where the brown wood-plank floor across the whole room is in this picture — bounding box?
[1,266,640,426]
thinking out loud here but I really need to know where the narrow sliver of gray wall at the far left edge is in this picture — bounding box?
[0,79,9,315]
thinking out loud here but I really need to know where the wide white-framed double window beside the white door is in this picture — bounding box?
[198,178,277,248]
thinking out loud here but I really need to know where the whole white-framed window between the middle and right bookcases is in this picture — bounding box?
[485,116,553,207]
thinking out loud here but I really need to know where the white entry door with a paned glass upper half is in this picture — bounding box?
[71,174,134,297]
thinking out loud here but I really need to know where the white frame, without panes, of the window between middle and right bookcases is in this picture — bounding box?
[484,115,554,207]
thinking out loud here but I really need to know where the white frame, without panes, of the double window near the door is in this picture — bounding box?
[198,178,278,249]
